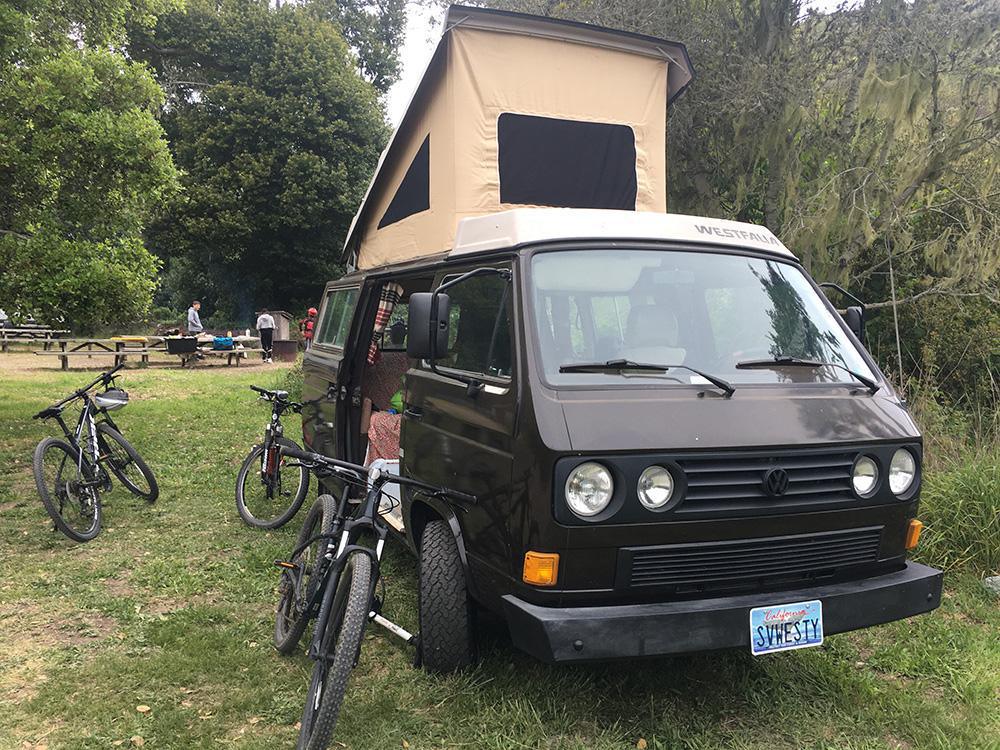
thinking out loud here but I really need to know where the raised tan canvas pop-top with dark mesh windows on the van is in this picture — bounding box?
[343,6,693,269]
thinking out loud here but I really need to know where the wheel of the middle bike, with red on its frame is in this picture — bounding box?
[236,437,309,529]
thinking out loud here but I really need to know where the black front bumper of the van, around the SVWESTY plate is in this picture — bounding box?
[503,562,944,662]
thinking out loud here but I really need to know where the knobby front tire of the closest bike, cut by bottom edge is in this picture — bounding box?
[298,552,372,750]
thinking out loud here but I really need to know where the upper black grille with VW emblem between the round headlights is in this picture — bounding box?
[676,450,857,514]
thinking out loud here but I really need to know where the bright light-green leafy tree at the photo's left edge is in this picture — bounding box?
[0,0,176,331]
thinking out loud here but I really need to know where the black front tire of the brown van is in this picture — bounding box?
[419,520,476,673]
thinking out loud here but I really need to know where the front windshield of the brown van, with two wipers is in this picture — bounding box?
[531,249,876,385]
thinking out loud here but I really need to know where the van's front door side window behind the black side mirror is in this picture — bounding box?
[438,276,513,378]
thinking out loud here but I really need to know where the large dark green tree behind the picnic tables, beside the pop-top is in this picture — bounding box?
[131,0,387,321]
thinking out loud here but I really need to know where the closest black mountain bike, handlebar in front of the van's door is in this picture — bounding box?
[274,448,476,750]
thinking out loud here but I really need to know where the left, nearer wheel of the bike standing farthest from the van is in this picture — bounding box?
[32,438,101,542]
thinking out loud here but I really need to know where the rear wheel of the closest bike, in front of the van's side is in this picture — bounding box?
[274,495,337,655]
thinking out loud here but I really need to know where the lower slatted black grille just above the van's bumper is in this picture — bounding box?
[617,526,882,593]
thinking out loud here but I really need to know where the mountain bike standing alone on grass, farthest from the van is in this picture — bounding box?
[33,364,160,542]
